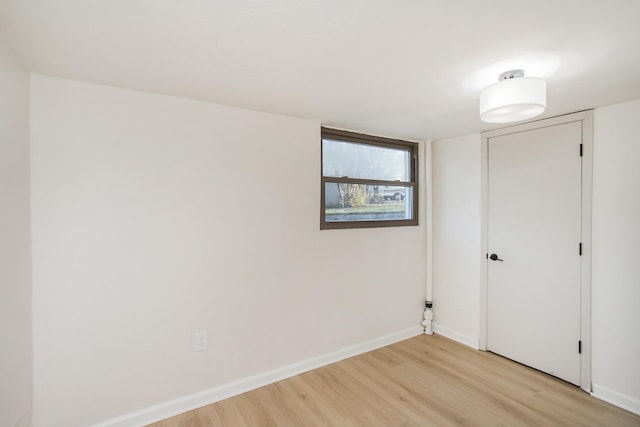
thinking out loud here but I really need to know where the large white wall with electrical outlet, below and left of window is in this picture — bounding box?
[31,76,425,426]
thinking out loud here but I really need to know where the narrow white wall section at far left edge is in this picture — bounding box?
[0,39,33,426]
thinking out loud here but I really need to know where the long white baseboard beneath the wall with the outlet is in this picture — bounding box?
[93,326,424,427]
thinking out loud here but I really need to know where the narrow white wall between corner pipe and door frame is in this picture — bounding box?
[431,134,482,348]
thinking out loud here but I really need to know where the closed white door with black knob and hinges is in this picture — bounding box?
[487,122,582,385]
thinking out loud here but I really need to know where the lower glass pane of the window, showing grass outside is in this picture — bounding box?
[324,182,413,222]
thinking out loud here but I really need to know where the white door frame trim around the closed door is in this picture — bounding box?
[478,110,593,393]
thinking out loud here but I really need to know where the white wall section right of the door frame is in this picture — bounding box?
[591,100,640,413]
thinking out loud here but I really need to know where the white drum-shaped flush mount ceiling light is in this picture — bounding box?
[480,70,547,123]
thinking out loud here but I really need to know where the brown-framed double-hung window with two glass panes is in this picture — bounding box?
[320,128,418,229]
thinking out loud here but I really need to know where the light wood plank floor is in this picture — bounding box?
[152,335,640,427]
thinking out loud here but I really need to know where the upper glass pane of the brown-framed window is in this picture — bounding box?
[322,139,411,182]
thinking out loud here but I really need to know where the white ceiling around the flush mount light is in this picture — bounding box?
[0,0,640,139]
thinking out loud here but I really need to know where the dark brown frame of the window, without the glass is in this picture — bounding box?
[320,126,420,230]
